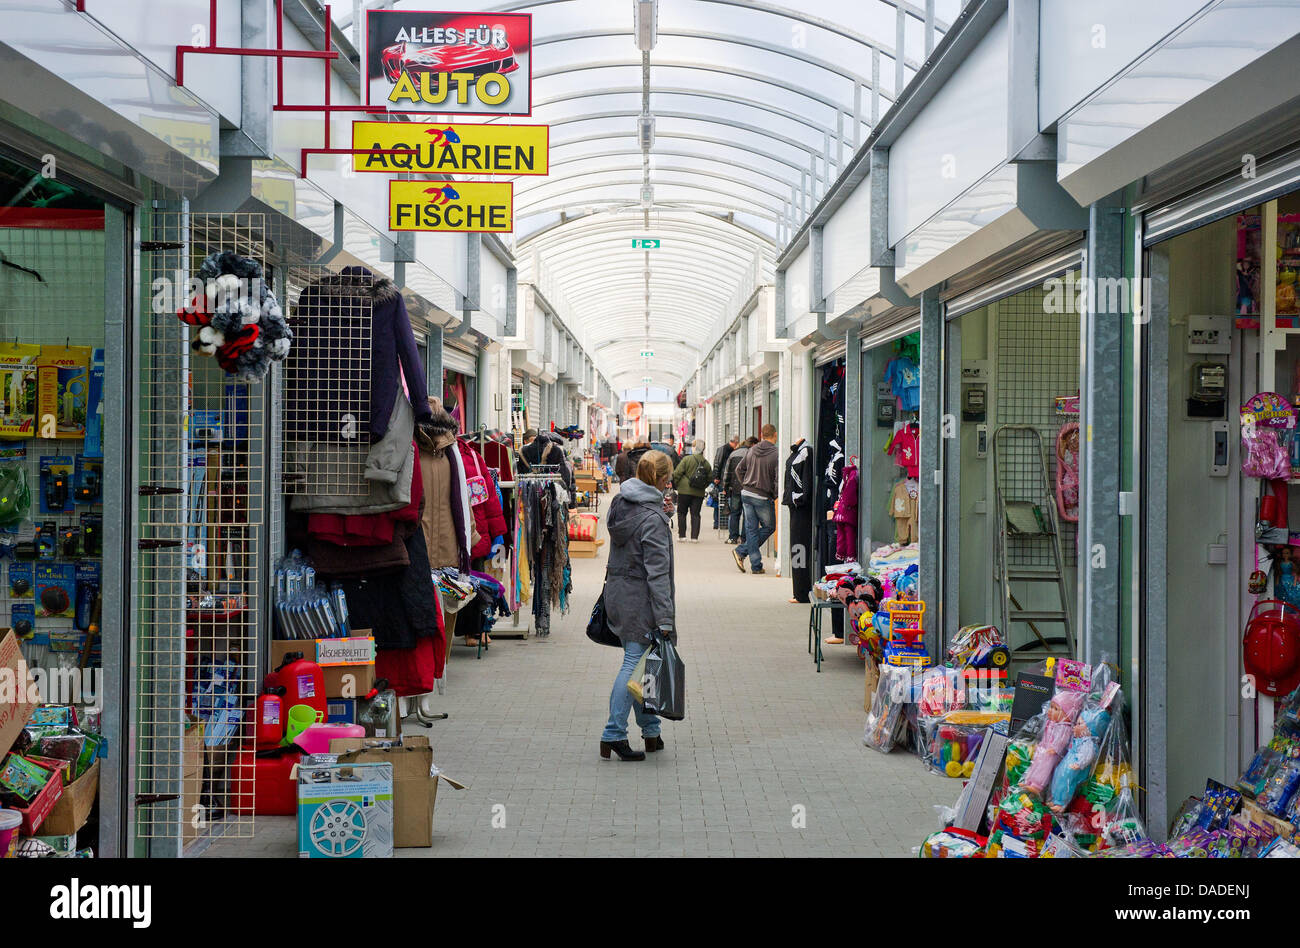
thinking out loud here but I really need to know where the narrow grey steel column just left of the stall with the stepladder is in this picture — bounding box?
[917,289,944,655]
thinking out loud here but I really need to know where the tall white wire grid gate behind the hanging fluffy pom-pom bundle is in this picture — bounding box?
[134,205,267,841]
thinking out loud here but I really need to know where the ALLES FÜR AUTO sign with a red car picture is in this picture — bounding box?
[365,10,533,116]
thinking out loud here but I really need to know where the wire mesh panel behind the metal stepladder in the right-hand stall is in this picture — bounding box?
[997,279,1079,567]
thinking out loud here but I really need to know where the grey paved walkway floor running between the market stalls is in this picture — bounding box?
[208,488,958,857]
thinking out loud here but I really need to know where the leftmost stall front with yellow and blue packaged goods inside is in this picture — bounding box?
[0,109,142,856]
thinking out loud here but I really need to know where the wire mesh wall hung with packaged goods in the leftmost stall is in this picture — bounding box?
[0,226,105,676]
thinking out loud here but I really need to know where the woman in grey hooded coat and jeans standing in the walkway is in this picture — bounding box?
[601,451,677,761]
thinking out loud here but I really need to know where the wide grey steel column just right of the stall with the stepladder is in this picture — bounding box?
[1076,195,1130,663]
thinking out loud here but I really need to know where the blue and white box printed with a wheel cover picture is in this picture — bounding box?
[298,754,393,860]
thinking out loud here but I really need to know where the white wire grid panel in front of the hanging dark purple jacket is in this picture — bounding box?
[281,265,374,497]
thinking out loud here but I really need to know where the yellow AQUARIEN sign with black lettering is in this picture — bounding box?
[352,122,551,174]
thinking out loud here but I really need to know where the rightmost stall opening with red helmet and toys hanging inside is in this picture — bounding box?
[1140,144,1300,822]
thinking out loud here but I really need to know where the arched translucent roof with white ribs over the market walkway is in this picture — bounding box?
[334,0,962,390]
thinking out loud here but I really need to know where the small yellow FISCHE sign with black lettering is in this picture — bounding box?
[389,181,515,234]
